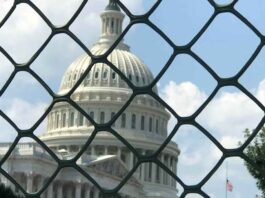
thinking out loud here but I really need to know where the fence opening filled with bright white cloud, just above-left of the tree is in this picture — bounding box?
[197,87,264,148]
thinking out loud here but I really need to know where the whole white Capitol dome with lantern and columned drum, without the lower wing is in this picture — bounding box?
[40,0,180,198]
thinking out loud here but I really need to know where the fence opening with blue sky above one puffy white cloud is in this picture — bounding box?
[155,54,217,116]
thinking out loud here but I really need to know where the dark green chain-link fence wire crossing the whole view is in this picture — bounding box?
[0,0,265,197]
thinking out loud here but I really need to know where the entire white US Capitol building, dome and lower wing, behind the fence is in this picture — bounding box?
[0,0,180,198]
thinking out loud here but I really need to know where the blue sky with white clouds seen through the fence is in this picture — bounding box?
[0,0,265,198]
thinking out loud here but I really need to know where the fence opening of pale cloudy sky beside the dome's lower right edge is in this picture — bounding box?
[168,125,222,185]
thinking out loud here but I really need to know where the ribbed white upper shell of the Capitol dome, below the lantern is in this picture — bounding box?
[59,43,157,94]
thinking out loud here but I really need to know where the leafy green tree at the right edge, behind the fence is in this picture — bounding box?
[241,127,265,198]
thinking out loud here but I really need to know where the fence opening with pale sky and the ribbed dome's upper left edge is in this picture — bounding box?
[31,34,85,94]
